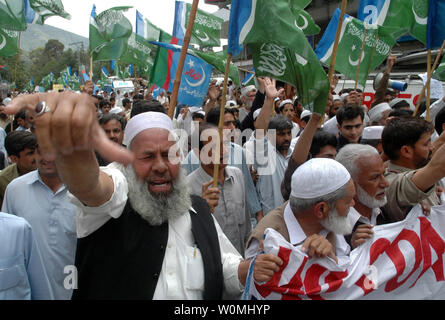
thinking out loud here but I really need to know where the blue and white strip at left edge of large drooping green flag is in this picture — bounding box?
[227,0,251,56]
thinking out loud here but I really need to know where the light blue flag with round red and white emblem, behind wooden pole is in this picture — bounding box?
[149,41,213,107]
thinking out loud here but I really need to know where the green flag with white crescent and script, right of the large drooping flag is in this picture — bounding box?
[317,16,396,86]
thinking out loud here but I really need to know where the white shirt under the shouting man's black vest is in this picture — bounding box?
[70,163,244,300]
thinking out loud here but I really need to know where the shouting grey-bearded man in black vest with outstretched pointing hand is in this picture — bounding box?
[5,92,283,300]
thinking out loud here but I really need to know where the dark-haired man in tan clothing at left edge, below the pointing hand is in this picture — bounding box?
[0,131,37,205]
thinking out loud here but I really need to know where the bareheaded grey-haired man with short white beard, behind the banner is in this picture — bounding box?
[335,143,389,248]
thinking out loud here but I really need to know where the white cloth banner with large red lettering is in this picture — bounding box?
[245,205,445,300]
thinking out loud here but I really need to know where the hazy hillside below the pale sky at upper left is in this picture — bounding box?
[20,24,88,52]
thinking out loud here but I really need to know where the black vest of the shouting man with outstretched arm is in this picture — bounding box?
[72,196,223,300]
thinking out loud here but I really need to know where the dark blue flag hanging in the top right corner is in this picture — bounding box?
[426,0,445,49]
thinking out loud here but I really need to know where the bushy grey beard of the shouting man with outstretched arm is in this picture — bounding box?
[119,165,192,226]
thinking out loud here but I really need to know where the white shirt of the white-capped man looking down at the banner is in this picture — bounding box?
[245,203,351,259]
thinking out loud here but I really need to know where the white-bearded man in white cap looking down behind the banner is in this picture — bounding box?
[246,158,355,259]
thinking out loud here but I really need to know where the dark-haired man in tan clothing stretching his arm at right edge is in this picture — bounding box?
[382,117,445,222]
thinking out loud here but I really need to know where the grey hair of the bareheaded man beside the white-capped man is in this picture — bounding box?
[335,143,379,179]
